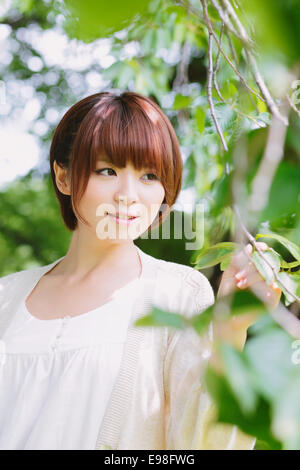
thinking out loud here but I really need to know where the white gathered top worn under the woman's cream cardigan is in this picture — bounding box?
[0,277,142,450]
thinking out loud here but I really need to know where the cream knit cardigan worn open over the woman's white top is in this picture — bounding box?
[0,247,256,450]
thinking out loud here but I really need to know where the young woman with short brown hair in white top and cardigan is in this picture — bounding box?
[0,92,282,449]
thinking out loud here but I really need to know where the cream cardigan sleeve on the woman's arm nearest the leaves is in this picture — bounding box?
[164,270,256,450]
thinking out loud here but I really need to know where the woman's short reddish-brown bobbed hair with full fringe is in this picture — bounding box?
[50,91,183,230]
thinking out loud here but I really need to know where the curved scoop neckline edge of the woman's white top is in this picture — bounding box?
[21,245,146,322]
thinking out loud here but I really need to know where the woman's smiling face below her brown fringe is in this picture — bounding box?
[78,156,165,240]
